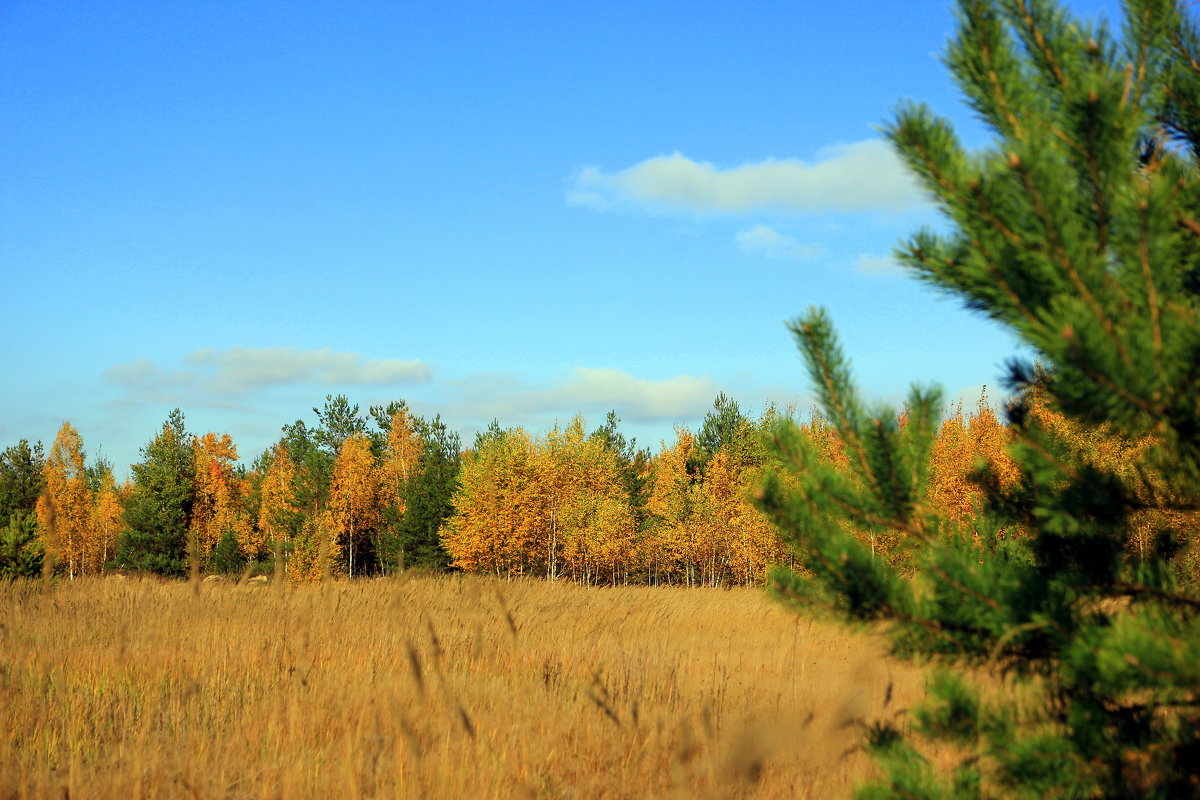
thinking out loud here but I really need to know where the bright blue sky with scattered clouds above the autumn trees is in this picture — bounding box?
[0,0,1114,474]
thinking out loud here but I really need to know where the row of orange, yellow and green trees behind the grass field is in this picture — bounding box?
[0,383,1123,587]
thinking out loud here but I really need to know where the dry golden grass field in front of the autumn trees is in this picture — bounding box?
[0,576,923,800]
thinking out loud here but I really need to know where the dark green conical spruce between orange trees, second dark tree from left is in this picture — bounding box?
[116,408,196,576]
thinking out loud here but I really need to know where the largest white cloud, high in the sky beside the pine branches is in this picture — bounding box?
[566,139,925,213]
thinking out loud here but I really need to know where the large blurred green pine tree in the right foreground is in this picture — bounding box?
[762,0,1200,799]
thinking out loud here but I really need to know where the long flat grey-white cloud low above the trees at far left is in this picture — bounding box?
[103,347,431,407]
